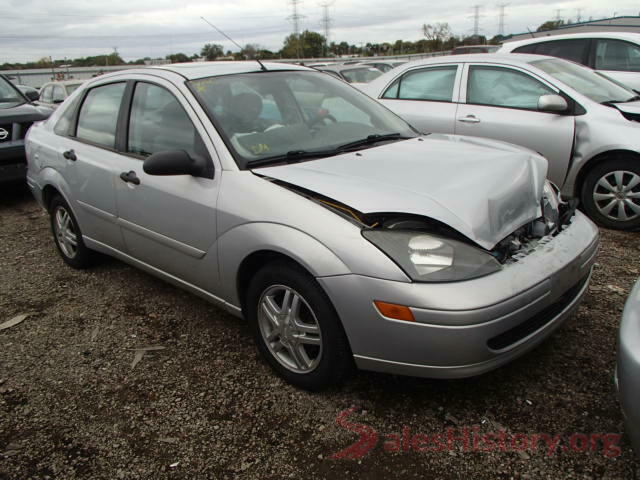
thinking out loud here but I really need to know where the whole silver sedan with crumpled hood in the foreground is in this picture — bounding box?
[27,62,598,389]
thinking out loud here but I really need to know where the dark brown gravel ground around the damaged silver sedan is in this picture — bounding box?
[0,187,640,480]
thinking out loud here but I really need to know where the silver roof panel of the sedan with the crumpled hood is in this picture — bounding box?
[148,60,312,80]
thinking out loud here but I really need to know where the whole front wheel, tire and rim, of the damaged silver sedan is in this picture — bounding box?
[246,261,353,391]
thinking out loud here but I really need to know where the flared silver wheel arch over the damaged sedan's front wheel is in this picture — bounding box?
[218,222,352,305]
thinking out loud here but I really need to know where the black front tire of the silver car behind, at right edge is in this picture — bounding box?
[580,157,640,230]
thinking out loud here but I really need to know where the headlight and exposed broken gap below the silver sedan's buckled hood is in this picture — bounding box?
[275,180,577,283]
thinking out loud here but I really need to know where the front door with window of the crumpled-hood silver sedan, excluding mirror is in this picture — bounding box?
[115,78,222,291]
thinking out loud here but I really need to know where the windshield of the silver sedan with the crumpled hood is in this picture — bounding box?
[188,71,417,168]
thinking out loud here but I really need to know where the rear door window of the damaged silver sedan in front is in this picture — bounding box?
[76,83,125,148]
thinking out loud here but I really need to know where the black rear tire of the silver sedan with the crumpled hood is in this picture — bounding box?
[49,195,97,270]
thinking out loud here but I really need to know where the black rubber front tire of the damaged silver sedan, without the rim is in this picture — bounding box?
[245,261,353,391]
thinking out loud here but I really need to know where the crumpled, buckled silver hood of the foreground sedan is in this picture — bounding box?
[253,134,547,249]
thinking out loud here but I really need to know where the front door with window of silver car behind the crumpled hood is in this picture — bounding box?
[455,63,575,186]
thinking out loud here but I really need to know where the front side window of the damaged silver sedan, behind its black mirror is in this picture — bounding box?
[127,82,204,157]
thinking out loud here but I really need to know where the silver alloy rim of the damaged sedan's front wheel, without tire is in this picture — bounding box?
[258,285,322,374]
